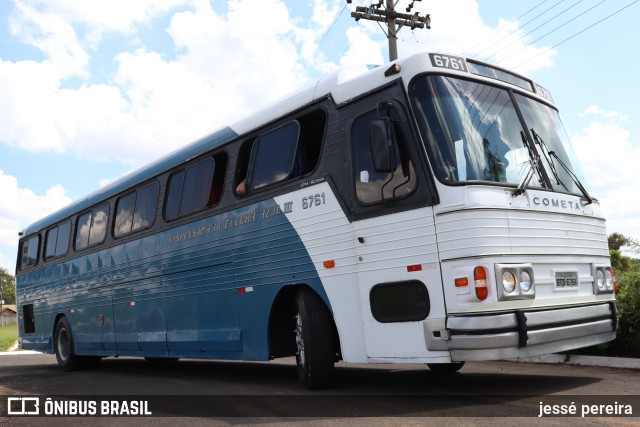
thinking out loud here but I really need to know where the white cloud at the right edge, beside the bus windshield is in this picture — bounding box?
[571,106,640,244]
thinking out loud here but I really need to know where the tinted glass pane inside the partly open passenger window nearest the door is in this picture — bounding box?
[250,121,300,190]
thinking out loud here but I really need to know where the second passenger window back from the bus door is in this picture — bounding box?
[164,153,227,221]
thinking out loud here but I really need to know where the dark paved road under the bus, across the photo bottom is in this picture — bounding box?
[0,354,640,427]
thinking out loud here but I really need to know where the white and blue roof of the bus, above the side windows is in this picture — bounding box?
[20,53,551,236]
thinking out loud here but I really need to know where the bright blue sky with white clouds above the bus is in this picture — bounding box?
[0,0,640,273]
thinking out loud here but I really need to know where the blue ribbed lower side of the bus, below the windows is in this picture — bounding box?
[18,199,328,360]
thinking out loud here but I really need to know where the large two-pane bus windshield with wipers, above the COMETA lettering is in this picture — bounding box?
[413,76,584,194]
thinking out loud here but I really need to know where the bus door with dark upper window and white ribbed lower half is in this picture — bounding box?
[350,85,445,361]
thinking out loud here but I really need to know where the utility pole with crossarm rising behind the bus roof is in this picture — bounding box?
[347,0,431,61]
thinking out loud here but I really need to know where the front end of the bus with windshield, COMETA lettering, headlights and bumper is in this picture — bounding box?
[409,55,616,361]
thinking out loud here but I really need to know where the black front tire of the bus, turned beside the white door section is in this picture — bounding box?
[294,288,336,390]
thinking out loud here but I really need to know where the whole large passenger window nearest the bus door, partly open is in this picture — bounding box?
[235,110,327,196]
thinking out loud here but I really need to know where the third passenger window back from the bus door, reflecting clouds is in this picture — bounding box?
[113,182,158,237]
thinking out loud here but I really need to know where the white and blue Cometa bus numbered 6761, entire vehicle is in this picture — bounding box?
[16,53,617,388]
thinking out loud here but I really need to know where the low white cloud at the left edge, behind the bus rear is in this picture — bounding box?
[0,169,71,272]
